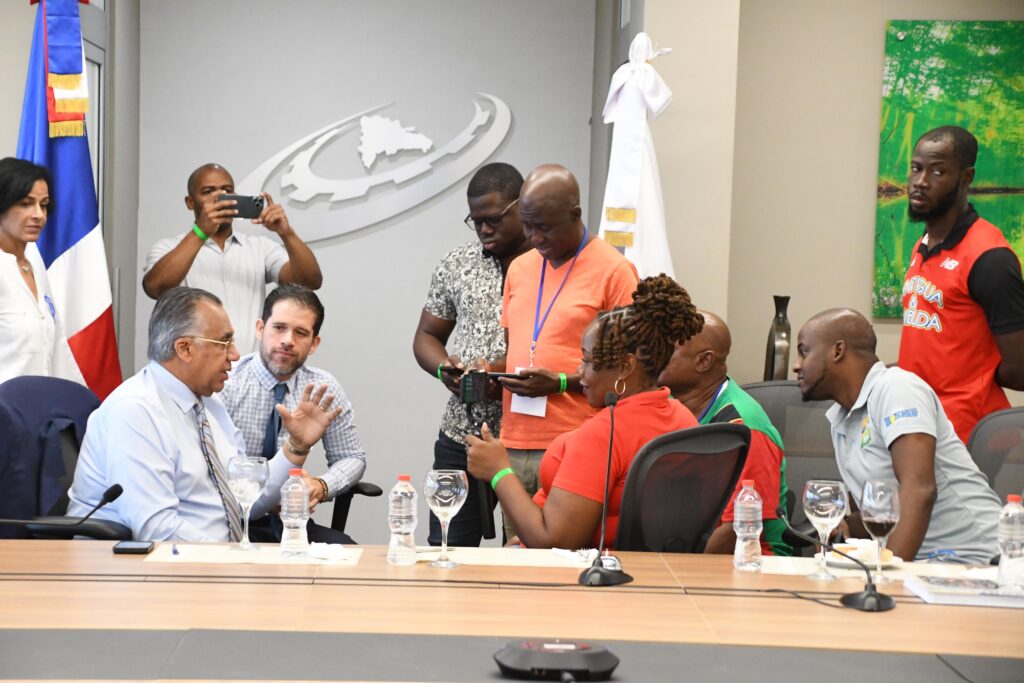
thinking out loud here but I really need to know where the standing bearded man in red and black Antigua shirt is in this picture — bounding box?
[899,126,1024,443]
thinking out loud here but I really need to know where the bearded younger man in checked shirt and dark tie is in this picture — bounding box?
[220,284,367,543]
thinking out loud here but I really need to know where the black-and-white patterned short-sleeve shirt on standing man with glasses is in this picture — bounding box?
[423,241,505,443]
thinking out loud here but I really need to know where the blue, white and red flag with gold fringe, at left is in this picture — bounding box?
[17,0,121,399]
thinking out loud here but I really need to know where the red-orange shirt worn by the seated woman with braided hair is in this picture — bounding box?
[534,387,697,548]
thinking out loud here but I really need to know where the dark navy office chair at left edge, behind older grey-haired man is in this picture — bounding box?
[0,377,131,540]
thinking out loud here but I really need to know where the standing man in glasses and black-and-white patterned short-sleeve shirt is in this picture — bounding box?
[413,163,530,546]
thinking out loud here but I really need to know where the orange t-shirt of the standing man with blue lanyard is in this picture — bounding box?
[501,238,639,450]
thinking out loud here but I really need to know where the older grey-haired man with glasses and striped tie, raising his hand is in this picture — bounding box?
[68,287,341,542]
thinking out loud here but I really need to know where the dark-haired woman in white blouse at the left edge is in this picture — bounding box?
[0,158,85,384]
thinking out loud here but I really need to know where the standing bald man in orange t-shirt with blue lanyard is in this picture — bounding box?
[496,164,639,538]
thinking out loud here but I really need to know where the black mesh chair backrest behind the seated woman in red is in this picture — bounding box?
[615,424,751,553]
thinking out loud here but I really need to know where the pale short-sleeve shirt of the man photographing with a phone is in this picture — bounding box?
[143,230,288,354]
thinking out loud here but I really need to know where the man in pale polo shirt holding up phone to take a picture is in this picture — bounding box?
[142,164,324,353]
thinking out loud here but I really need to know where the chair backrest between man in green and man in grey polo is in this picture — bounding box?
[743,380,841,523]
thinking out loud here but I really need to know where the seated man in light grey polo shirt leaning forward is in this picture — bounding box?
[794,308,1000,563]
